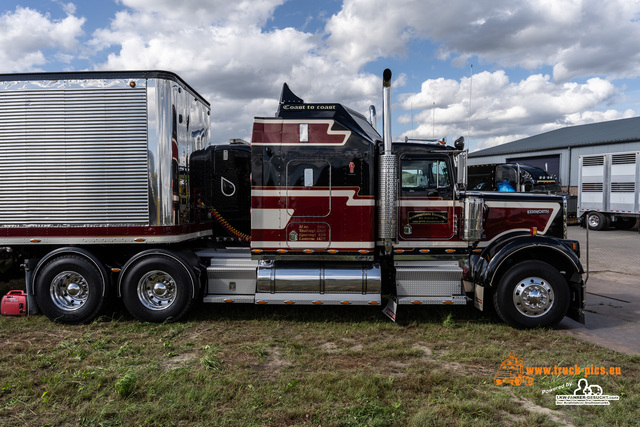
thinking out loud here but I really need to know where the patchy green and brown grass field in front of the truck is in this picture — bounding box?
[0,280,640,426]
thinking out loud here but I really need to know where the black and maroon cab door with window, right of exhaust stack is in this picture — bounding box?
[398,155,455,242]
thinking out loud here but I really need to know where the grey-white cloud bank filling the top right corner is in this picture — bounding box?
[327,0,640,81]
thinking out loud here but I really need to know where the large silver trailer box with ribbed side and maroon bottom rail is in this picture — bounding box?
[0,72,215,244]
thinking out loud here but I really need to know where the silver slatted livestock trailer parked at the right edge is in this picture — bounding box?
[578,152,640,230]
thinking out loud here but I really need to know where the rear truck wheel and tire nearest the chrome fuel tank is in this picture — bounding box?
[122,255,193,322]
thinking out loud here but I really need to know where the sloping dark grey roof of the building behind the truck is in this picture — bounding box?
[469,117,640,157]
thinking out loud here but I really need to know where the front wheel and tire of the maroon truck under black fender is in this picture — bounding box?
[493,261,569,329]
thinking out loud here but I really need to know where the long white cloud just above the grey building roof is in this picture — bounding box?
[398,70,633,147]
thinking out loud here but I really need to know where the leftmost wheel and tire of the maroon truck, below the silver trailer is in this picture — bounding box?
[35,255,108,324]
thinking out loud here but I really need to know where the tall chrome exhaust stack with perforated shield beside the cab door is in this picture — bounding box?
[378,68,398,254]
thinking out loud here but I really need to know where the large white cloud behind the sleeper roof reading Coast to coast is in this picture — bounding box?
[90,0,380,142]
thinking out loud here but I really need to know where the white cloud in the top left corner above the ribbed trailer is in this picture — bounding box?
[0,6,85,72]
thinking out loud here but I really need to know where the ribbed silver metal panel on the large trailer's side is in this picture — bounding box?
[0,87,149,226]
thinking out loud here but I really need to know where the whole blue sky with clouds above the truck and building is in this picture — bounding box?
[0,0,640,150]
